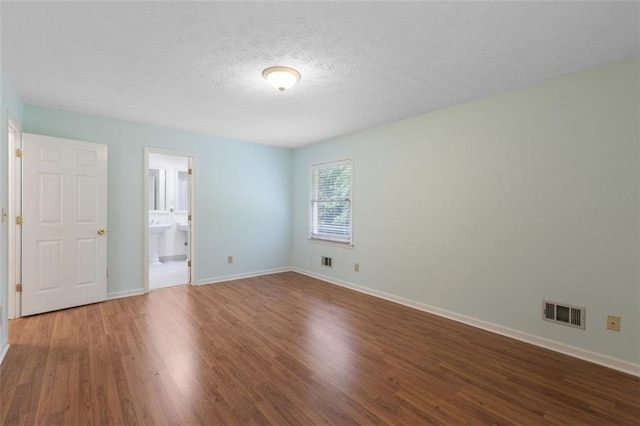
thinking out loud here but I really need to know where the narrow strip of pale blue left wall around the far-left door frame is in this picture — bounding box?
[0,68,23,352]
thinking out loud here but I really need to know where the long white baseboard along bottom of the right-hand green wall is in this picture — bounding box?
[291,268,640,377]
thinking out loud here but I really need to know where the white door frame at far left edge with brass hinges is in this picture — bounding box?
[7,115,22,319]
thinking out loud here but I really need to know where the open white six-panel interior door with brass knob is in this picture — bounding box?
[22,133,107,315]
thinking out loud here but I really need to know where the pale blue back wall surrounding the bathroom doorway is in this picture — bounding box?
[24,105,292,295]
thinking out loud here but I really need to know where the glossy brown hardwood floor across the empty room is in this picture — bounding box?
[0,273,640,425]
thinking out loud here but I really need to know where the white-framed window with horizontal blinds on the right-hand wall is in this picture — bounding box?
[311,159,352,244]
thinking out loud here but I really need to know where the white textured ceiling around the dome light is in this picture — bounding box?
[0,1,640,147]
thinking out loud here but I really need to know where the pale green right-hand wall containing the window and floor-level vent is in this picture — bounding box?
[292,59,640,363]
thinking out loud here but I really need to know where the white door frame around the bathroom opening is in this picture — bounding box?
[142,146,198,293]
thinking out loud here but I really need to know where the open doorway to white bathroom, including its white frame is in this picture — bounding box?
[144,148,195,291]
